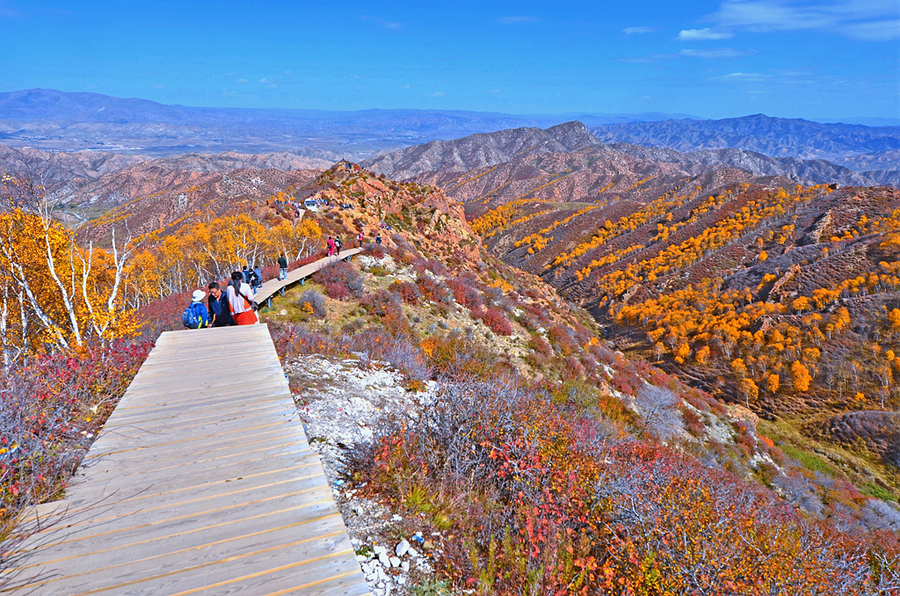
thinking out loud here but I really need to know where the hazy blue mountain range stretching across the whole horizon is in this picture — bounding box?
[0,89,900,184]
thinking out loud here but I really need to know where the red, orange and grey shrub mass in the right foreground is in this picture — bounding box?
[353,378,900,595]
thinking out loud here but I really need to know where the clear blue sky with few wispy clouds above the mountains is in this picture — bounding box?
[0,0,900,119]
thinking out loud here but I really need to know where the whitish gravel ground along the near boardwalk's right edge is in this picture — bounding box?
[285,356,440,596]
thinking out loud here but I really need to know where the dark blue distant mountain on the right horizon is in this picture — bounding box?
[592,114,900,184]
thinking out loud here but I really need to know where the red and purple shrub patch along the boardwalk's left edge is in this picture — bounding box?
[0,340,152,522]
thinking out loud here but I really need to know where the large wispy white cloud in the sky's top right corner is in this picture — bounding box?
[710,0,900,41]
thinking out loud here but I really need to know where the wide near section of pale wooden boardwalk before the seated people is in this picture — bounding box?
[7,325,368,595]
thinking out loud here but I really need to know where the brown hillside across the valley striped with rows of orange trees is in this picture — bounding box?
[362,129,900,508]
